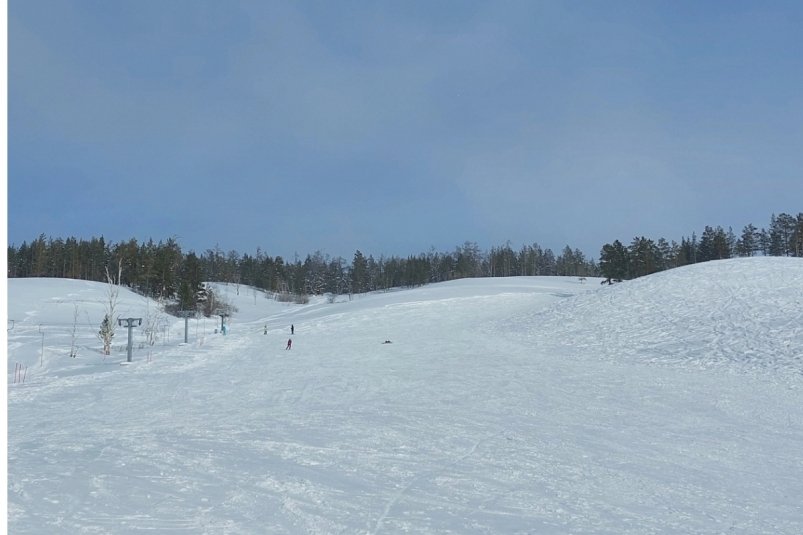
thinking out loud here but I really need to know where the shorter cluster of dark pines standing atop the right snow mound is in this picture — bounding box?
[599,213,803,280]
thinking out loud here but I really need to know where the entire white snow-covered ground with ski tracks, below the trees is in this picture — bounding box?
[8,258,803,535]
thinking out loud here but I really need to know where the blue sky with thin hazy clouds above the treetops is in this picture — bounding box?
[8,0,803,258]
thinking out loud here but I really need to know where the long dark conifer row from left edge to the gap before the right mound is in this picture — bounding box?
[8,234,598,309]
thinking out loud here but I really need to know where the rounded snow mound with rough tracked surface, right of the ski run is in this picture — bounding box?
[525,257,803,374]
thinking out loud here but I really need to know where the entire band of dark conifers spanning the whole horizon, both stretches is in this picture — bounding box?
[7,212,803,310]
